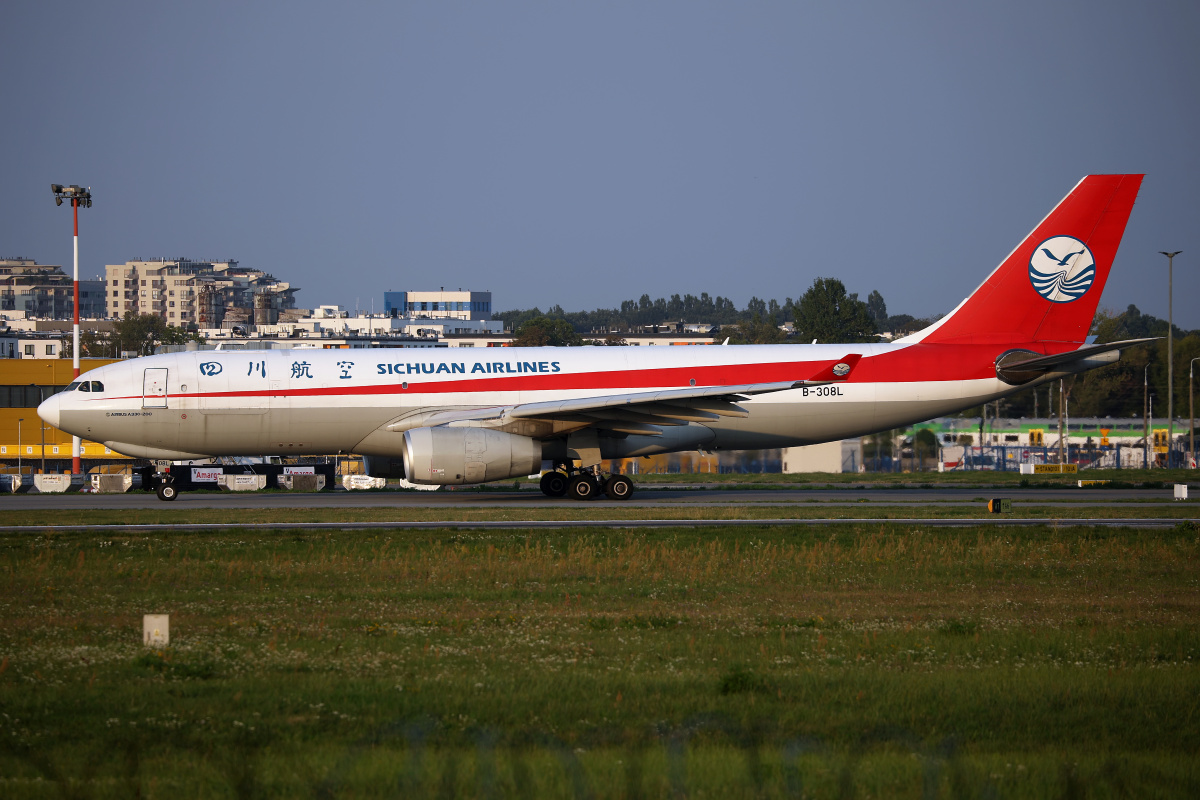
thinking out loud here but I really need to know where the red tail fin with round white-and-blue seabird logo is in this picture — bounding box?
[901,175,1142,343]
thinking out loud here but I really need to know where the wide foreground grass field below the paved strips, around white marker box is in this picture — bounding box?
[0,522,1200,800]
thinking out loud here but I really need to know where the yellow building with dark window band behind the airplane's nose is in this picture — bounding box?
[0,359,128,473]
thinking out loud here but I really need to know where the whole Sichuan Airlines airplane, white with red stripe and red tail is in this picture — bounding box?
[37,175,1150,500]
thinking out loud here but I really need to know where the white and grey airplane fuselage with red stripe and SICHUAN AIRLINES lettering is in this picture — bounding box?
[40,343,1032,458]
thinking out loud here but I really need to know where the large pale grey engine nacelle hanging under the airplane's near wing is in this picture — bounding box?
[404,427,541,485]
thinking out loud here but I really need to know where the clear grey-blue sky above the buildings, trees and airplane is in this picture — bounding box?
[0,0,1200,327]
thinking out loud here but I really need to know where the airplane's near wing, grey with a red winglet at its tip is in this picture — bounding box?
[389,354,862,435]
